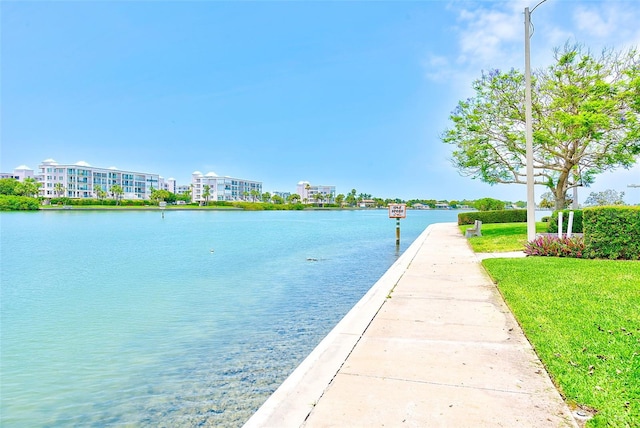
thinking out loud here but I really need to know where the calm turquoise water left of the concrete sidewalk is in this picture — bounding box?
[0,210,457,427]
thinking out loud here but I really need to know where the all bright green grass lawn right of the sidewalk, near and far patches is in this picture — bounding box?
[461,223,640,427]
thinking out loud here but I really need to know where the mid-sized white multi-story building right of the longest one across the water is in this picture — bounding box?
[191,171,262,202]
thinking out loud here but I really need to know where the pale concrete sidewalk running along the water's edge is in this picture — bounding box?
[245,223,578,427]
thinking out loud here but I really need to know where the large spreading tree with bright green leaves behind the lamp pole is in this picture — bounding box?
[441,45,640,209]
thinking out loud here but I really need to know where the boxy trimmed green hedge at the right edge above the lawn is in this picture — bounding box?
[584,206,640,260]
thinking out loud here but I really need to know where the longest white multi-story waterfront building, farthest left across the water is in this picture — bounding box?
[36,159,163,199]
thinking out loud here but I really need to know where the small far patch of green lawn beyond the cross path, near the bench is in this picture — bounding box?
[460,222,548,253]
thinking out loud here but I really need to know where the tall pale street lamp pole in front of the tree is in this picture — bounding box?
[524,0,547,241]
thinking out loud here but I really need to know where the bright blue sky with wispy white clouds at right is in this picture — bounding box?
[0,0,640,203]
